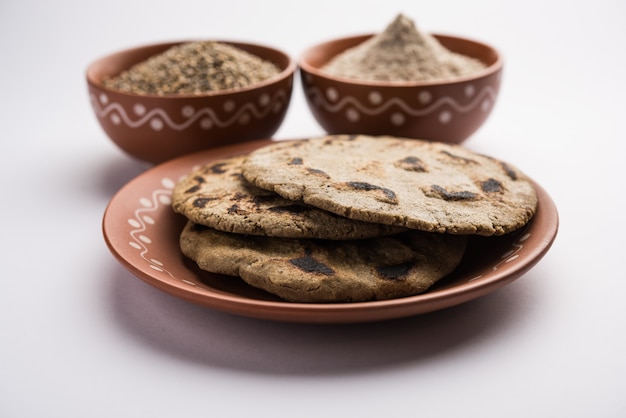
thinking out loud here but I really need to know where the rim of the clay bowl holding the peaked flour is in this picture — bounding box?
[298,33,504,87]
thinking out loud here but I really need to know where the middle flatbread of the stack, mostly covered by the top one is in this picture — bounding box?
[172,156,405,240]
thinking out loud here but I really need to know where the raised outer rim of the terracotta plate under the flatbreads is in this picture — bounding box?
[101,139,559,323]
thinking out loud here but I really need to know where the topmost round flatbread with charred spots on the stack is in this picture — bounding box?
[242,135,537,236]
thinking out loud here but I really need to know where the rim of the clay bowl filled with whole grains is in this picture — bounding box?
[85,38,298,100]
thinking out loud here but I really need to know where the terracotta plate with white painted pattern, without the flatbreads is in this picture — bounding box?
[102,140,558,323]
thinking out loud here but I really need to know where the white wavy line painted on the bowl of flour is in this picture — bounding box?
[307,86,496,116]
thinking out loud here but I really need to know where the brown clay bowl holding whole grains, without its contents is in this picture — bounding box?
[87,41,296,163]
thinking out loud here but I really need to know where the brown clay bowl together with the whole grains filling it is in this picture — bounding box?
[86,40,296,164]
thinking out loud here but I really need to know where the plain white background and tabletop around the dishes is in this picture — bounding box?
[0,0,626,418]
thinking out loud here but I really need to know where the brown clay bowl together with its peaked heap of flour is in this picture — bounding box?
[299,15,503,143]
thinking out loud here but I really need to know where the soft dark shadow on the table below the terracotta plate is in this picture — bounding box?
[109,261,523,375]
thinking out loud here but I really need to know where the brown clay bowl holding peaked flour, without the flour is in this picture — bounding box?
[299,34,503,144]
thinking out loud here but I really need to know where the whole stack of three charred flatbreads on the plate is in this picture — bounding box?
[173,135,537,303]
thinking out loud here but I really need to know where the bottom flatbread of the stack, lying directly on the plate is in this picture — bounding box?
[180,222,467,303]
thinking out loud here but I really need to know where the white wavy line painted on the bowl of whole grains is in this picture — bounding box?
[90,90,287,131]
